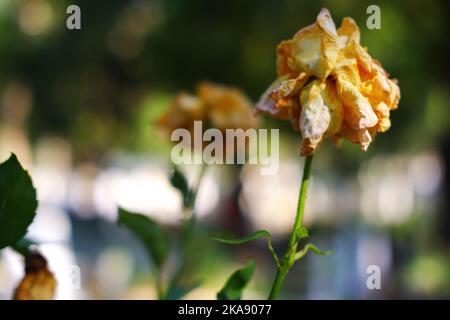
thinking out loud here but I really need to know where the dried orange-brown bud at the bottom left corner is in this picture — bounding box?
[14,252,56,300]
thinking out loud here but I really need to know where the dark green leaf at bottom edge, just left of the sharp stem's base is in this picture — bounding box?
[217,259,255,300]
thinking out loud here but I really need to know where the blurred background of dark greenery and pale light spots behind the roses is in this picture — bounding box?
[0,0,450,299]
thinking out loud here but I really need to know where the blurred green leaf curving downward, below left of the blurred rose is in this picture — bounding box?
[119,208,170,269]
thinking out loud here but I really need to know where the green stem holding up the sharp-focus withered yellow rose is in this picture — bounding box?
[269,155,313,300]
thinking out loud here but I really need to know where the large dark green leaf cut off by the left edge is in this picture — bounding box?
[0,154,38,249]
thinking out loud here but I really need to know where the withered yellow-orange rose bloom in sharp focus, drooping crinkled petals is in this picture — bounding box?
[256,9,400,156]
